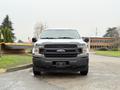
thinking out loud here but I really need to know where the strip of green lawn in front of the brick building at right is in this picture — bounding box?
[96,51,120,57]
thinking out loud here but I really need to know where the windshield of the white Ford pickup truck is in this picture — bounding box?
[40,29,80,39]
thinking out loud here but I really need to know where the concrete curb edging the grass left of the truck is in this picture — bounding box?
[6,64,33,72]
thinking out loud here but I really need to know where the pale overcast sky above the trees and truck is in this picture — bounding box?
[0,0,120,40]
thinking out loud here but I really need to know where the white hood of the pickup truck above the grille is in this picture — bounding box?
[35,39,86,45]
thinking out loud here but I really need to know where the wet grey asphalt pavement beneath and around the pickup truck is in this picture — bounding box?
[0,54,120,90]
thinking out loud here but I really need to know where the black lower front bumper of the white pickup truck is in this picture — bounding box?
[33,56,89,72]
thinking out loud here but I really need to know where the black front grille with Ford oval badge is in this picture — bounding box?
[44,44,79,58]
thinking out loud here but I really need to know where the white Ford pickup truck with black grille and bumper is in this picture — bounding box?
[32,29,89,76]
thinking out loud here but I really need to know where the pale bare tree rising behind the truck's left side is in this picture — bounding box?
[34,23,47,39]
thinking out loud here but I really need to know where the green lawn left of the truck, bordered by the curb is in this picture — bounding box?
[0,55,32,69]
